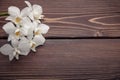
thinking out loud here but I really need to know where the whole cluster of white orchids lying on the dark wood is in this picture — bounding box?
[0,1,49,61]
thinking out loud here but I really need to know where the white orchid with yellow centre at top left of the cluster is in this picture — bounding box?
[6,6,30,25]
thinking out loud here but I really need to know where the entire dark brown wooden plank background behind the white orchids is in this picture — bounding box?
[0,0,120,80]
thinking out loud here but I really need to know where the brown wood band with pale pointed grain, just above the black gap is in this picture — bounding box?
[0,13,120,37]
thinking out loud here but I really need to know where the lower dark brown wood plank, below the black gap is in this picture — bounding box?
[0,39,120,80]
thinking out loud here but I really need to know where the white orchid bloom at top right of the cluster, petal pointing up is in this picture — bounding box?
[25,1,44,23]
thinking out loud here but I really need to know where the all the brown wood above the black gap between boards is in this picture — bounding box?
[0,0,120,37]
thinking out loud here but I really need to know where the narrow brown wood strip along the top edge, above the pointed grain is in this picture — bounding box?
[0,0,120,14]
